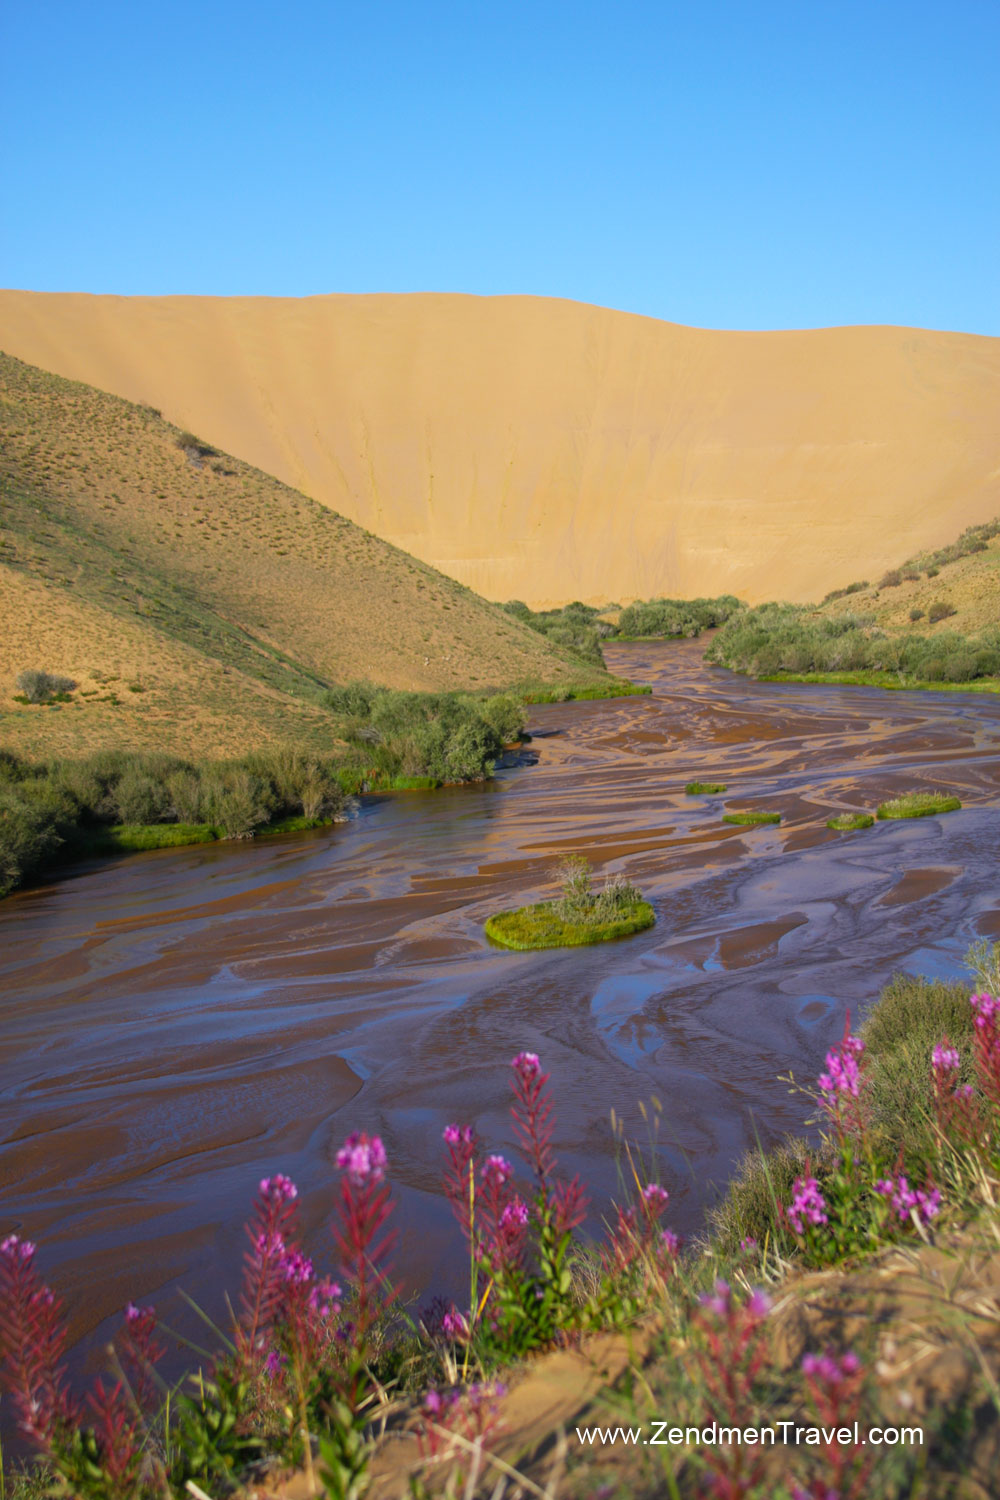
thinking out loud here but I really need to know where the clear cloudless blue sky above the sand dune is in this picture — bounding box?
[0,0,1000,335]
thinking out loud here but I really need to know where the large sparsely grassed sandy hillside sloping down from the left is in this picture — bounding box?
[0,356,610,755]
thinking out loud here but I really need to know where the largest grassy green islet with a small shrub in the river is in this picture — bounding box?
[486,858,657,950]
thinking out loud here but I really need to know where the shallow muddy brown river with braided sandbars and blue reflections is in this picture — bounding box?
[0,642,1000,1392]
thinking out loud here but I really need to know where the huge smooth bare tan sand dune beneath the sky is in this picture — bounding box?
[0,291,1000,605]
